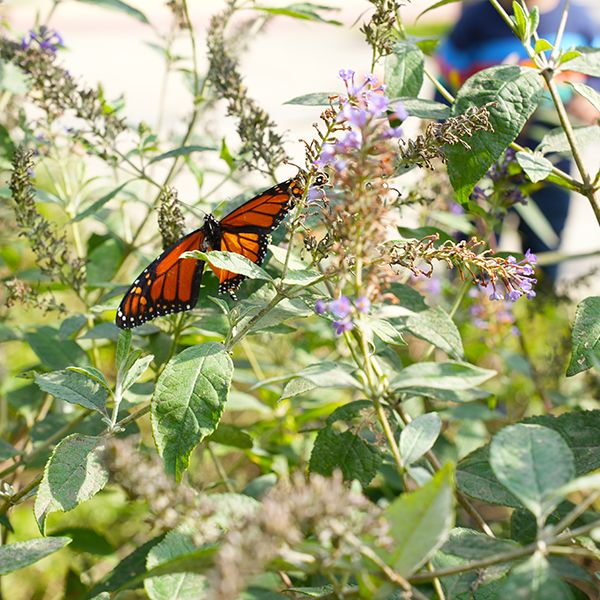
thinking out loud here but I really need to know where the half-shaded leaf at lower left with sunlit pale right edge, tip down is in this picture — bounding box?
[34,433,108,534]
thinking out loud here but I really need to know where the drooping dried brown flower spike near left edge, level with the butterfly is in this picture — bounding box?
[9,147,85,291]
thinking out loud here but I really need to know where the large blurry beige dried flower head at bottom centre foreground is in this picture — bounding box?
[209,472,390,600]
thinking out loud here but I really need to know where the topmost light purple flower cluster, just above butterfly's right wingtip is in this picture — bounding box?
[316,69,408,172]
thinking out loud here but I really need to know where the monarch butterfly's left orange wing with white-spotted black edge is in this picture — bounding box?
[116,228,205,329]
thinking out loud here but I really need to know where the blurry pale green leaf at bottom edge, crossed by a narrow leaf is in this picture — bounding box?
[144,531,208,600]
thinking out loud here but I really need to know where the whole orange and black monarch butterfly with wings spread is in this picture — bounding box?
[115,175,325,329]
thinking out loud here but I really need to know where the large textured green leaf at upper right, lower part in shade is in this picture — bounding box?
[445,65,544,203]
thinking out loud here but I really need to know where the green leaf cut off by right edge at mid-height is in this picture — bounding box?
[567,296,600,377]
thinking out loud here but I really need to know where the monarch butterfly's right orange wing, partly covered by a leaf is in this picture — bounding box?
[211,179,303,298]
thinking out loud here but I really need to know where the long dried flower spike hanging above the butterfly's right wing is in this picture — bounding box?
[207,2,286,173]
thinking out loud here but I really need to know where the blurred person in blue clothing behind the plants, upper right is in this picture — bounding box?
[437,0,600,282]
